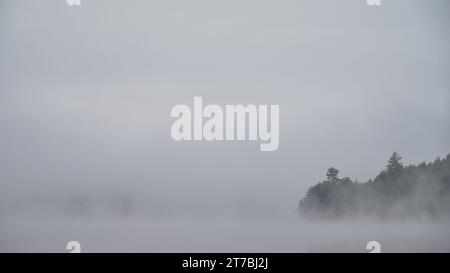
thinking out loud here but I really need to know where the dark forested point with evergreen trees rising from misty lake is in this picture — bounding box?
[298,153,450,219]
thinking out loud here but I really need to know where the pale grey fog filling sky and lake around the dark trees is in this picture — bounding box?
[0,0,450,252]
